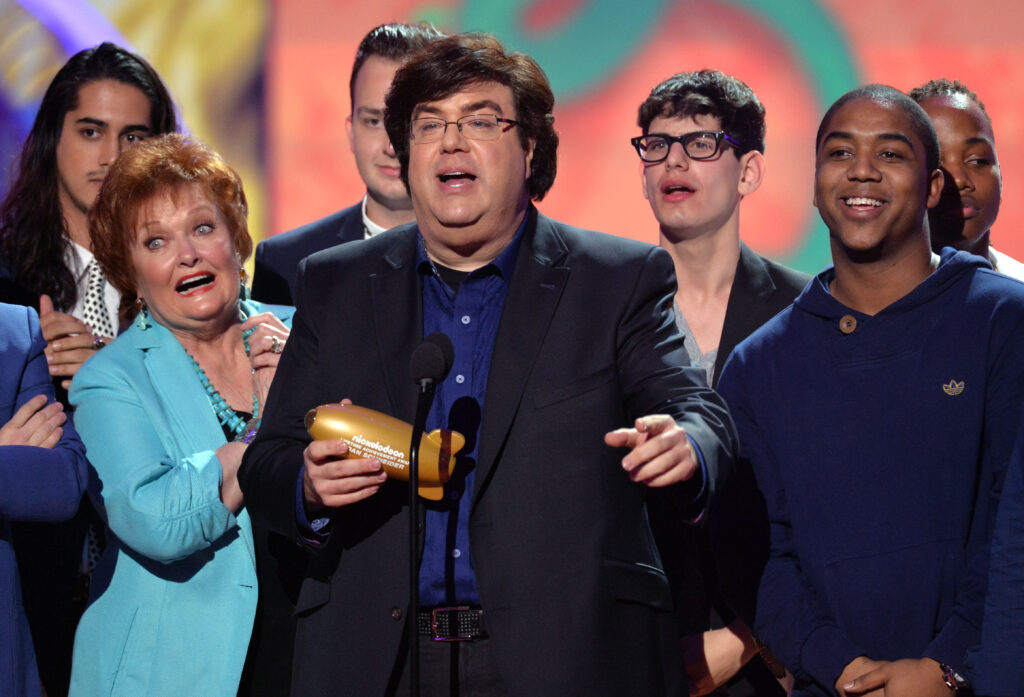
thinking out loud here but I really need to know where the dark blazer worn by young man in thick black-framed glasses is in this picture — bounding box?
[653,243,811,697]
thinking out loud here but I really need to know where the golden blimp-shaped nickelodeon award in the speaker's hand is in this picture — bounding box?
[306,404,466,500]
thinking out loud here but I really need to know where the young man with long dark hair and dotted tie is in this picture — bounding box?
[0,43,177,696]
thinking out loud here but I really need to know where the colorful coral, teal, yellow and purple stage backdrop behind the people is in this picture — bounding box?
[0,0,1024,271]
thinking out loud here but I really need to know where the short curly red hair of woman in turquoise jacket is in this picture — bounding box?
[89,133,253,322]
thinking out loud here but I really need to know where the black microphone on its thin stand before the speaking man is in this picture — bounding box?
[406,332,455,697]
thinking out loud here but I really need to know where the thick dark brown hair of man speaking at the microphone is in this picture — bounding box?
[384,33,558,201]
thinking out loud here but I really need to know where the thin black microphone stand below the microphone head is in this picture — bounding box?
[408,378,436,697]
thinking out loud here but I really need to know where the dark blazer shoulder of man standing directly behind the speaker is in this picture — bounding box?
[252,202,364,305]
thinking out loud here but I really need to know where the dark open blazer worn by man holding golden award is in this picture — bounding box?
[239,209,734,697]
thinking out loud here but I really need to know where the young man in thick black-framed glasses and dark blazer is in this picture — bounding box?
[632,70,810,696]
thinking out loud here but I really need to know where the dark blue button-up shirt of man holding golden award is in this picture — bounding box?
[417,218,525,607]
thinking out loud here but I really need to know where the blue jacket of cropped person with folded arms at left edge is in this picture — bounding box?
[0,304,89,697]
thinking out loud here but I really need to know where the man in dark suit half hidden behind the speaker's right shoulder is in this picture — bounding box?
[252,24,441,305]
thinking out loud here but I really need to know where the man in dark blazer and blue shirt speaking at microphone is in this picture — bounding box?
[239,35,734,697]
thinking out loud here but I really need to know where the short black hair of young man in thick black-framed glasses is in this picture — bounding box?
[637,70,765,158]
